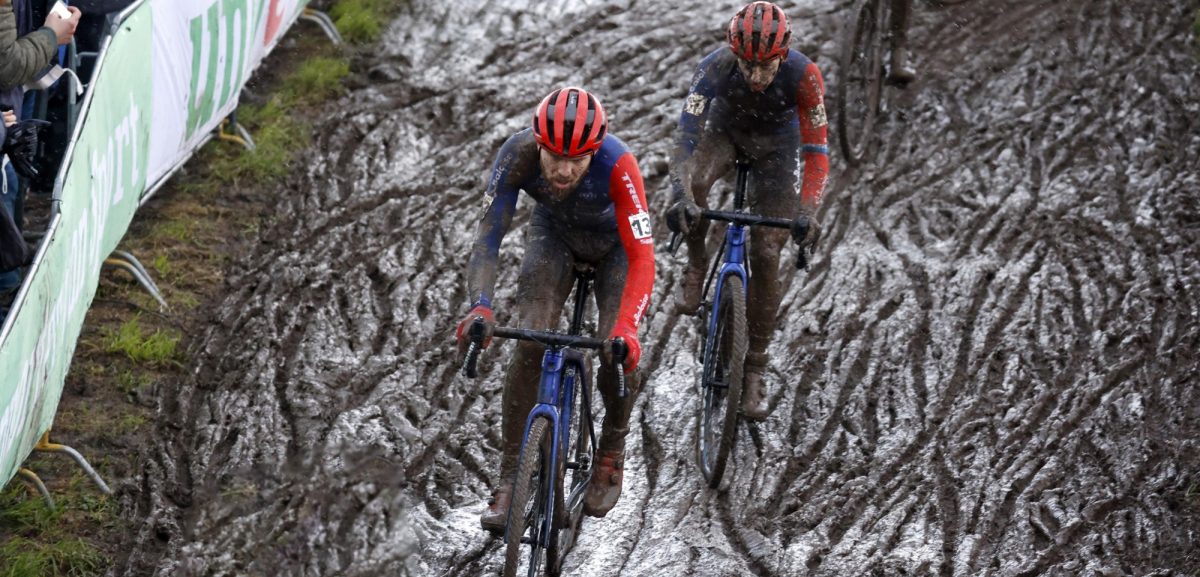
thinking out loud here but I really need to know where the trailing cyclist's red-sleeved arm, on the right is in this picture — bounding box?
[796,62,829,211]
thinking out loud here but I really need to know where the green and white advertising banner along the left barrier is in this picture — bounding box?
[0,0,306,485]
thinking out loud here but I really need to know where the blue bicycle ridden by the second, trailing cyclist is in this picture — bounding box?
[670,158,809,488]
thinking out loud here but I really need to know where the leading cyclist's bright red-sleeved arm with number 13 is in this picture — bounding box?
[608,152,654,333]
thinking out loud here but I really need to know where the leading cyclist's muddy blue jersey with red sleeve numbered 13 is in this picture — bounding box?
[467,128,654,338]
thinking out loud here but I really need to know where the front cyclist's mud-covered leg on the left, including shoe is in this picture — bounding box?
[481,216,575,530]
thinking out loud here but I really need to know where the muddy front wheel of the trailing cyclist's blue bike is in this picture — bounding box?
[696,275,746,488]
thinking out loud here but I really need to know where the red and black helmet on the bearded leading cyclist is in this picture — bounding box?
[533,86,608,156]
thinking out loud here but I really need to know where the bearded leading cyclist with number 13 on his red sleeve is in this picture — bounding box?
[457,88,654,533]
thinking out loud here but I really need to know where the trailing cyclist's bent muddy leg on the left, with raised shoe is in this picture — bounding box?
[676,128,734,313]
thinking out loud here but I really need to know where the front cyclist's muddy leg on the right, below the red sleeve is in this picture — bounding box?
[584,245,640,517]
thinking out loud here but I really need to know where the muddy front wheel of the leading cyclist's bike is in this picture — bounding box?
[504,417,552,577]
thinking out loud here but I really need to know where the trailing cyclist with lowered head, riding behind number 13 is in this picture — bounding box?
[666,1,829,419]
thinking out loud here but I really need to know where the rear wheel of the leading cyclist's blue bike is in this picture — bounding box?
[546,362,595,577]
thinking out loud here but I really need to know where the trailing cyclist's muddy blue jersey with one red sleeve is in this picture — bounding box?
[672,47,829,205]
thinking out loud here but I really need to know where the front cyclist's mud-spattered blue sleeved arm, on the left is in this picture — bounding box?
[467,137,521,307]
